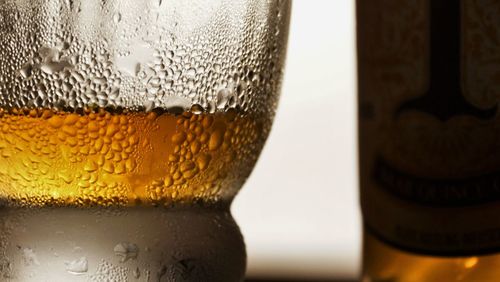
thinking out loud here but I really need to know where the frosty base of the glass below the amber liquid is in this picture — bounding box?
[0,207,246,282]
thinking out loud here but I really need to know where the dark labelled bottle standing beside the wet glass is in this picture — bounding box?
[357,0,500,282]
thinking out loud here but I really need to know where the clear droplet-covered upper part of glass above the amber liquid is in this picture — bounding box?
[0,0,288,113]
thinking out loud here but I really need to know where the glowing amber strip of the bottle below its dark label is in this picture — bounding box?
[361,232,500,282]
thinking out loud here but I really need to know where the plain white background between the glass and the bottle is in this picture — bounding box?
[232,0,361,281]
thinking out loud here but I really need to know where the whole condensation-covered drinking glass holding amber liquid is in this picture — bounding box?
[0,0,290,282]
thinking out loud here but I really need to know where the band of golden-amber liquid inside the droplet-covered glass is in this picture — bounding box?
[0,109,268,206]
